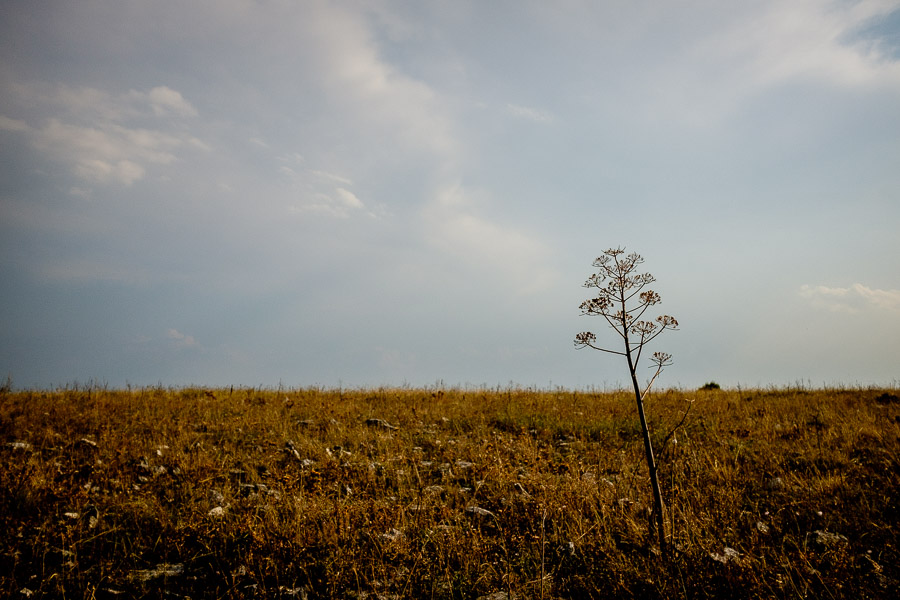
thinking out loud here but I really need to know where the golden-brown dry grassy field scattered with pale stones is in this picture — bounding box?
[0,387,900,600]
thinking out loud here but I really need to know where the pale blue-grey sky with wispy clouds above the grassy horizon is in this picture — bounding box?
[0,0,900,389]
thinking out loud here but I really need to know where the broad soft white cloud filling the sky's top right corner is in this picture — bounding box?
[633,0,900,127]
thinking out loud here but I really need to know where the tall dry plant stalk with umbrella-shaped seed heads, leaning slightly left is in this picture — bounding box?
[575,248,678,557]
